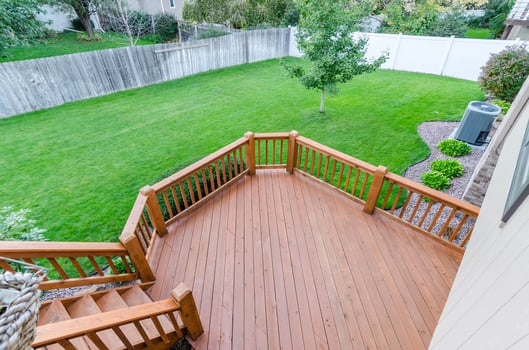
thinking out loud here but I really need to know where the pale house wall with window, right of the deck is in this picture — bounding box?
[430,78,529,349]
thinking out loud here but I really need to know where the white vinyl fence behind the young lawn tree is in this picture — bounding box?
[290,29,518,81]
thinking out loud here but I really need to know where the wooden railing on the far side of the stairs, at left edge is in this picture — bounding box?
[0,241,139,290]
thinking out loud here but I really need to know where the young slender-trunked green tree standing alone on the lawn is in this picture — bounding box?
[282,0,386,113]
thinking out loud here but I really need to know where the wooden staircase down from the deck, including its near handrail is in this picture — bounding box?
[33,283,198,350]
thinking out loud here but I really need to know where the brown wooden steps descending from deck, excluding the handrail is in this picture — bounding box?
[37,283,182,350]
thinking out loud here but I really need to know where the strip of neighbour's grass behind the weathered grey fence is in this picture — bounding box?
[0,33,153,62]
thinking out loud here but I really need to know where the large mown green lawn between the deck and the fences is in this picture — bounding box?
[0,60,483,241]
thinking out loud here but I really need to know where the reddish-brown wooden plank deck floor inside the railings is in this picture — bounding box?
[146,169,461,349]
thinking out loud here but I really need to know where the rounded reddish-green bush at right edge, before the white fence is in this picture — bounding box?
[478,45,529,102]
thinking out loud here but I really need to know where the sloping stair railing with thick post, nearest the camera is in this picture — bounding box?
[32,284,203,349]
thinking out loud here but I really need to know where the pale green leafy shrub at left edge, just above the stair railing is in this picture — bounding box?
[0,205,46,241]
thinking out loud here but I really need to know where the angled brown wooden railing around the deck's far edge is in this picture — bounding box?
[122,131,479,256]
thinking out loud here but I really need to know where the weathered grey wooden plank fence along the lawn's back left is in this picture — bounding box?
[0,28,290,118]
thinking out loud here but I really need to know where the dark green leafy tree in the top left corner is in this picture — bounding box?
[0,0,46,55]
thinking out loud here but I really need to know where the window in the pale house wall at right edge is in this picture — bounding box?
[502,123,529,222]
